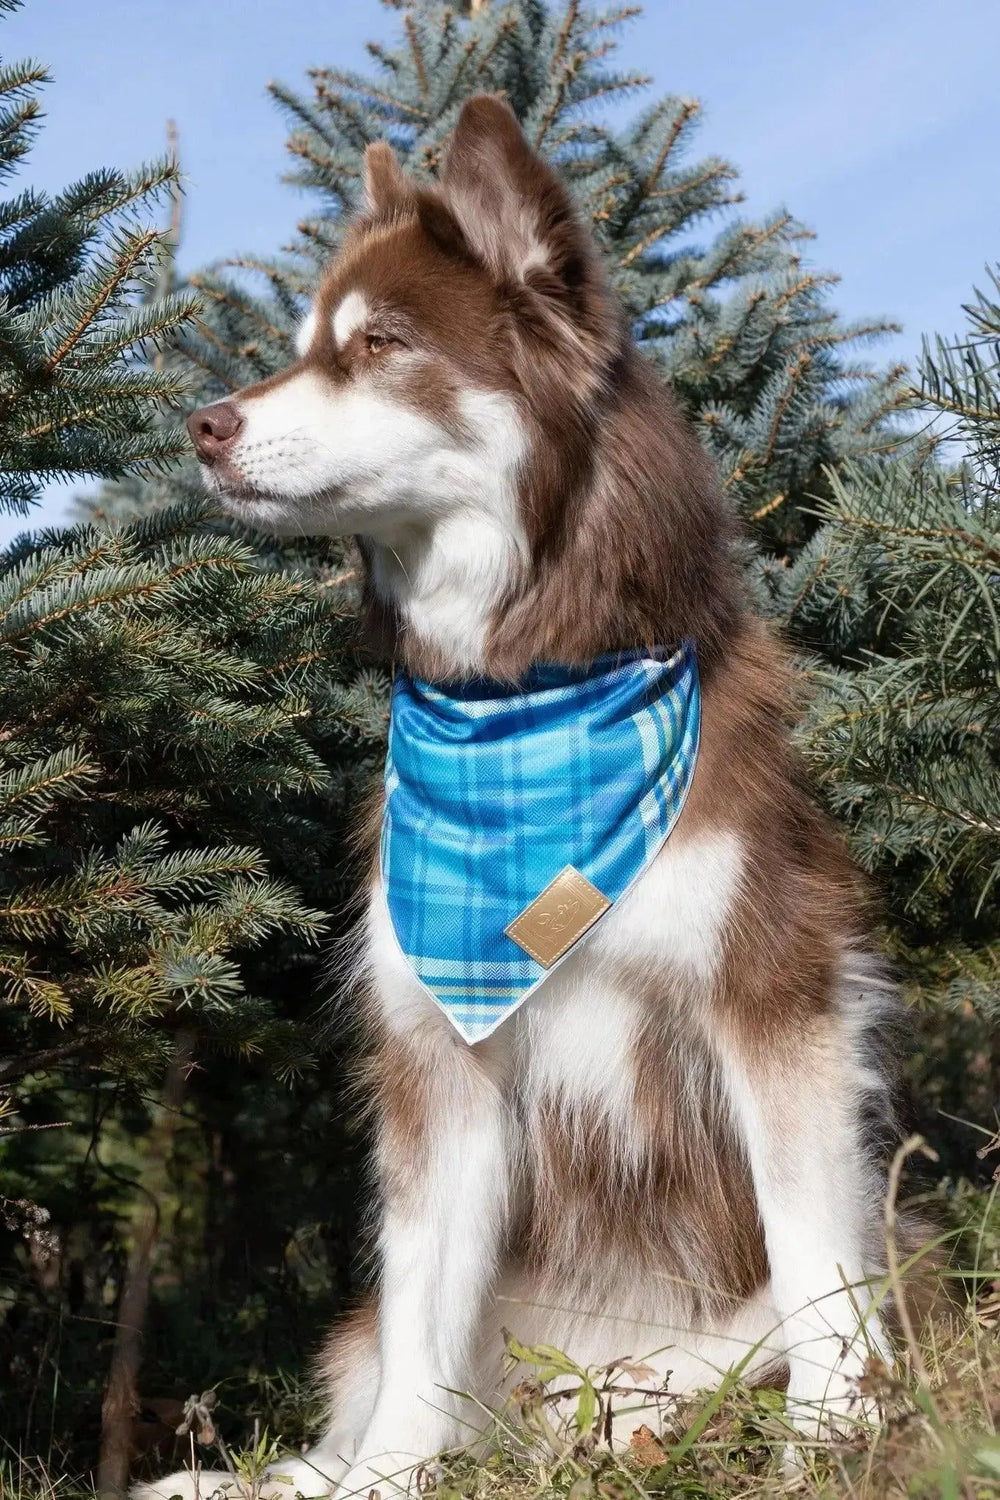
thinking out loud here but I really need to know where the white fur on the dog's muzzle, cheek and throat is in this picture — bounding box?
[204,369,528,672]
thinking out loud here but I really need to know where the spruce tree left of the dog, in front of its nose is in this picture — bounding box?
[0,0,378,1491]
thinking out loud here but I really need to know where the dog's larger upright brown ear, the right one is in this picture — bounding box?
[442,95,588,290]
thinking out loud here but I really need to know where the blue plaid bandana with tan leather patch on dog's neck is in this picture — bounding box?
[382,644,700,1043]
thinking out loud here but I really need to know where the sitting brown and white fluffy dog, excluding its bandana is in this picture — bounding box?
[145,96,894,1496]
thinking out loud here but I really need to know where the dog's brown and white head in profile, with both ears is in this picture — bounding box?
[182,95,622,564]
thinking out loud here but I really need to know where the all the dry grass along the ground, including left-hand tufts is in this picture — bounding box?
[7,1188,1000,1500]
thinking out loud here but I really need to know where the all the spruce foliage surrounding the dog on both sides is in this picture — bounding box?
[0,0,1000,1467]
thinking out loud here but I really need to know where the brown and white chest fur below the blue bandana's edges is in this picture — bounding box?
[367,819,765,1304]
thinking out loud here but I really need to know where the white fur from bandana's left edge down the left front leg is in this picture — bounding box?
[340,884,517,1496]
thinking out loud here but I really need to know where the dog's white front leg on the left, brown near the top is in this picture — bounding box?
[339,1017,511,1496]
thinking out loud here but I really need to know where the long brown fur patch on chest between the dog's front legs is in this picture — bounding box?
[520,1020,768,1320]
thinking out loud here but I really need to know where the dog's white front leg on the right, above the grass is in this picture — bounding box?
[723,1014,891,1437]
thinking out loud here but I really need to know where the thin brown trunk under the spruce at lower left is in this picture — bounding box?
[97,1032,193,1500]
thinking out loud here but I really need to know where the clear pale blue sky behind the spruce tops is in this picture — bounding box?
[0,0,1000,540]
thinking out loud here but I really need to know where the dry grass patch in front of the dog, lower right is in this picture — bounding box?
[428,1308,1000,1500]
